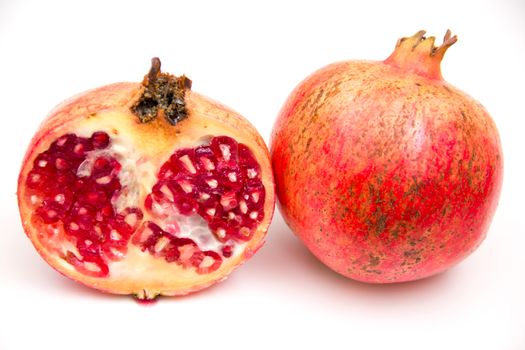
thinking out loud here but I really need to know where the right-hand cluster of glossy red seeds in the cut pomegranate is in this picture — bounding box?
[143,136,264,262]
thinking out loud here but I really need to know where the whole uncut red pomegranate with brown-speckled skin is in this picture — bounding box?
[270,31,503,283]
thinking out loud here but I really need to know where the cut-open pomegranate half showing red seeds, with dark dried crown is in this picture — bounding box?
[18,58,275,299]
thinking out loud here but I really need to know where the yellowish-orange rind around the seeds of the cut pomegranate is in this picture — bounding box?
[17,83,275,298]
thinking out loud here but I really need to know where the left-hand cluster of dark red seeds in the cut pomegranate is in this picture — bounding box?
[27,132,143,277]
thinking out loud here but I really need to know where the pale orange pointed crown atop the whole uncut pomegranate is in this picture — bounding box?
[384,30,458,79]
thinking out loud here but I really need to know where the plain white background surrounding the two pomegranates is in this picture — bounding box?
[0,0,525,350]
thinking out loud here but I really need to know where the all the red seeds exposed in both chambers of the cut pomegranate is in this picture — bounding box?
[27,132,264,277]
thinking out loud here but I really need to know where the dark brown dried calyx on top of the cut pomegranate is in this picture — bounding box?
[131,57,191,125]
